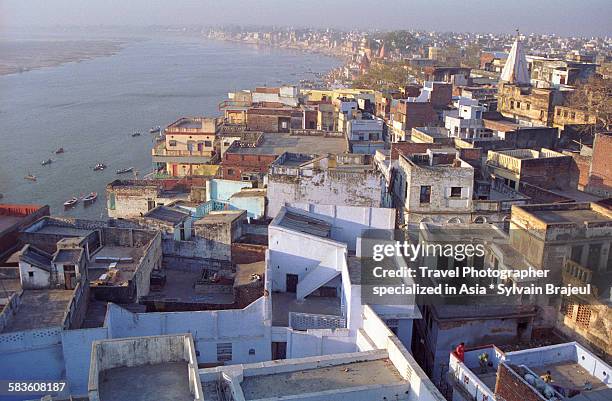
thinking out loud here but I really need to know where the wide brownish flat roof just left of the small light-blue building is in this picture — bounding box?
[229,133,348,156]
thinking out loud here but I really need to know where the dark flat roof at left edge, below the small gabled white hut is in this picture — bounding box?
[3,290,73,333]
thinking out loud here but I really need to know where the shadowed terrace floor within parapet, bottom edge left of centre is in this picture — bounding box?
[99,362,193,401]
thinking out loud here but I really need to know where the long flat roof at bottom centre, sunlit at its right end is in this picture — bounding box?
[241,358,404,400]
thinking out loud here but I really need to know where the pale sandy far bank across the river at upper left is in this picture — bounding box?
[0,40,126,76]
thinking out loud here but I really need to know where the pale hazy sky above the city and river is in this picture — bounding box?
[0,0,612,36]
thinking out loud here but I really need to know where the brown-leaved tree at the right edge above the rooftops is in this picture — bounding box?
[567,76,612,131]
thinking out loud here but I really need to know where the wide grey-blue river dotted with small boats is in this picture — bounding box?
[0,37,339,219]
